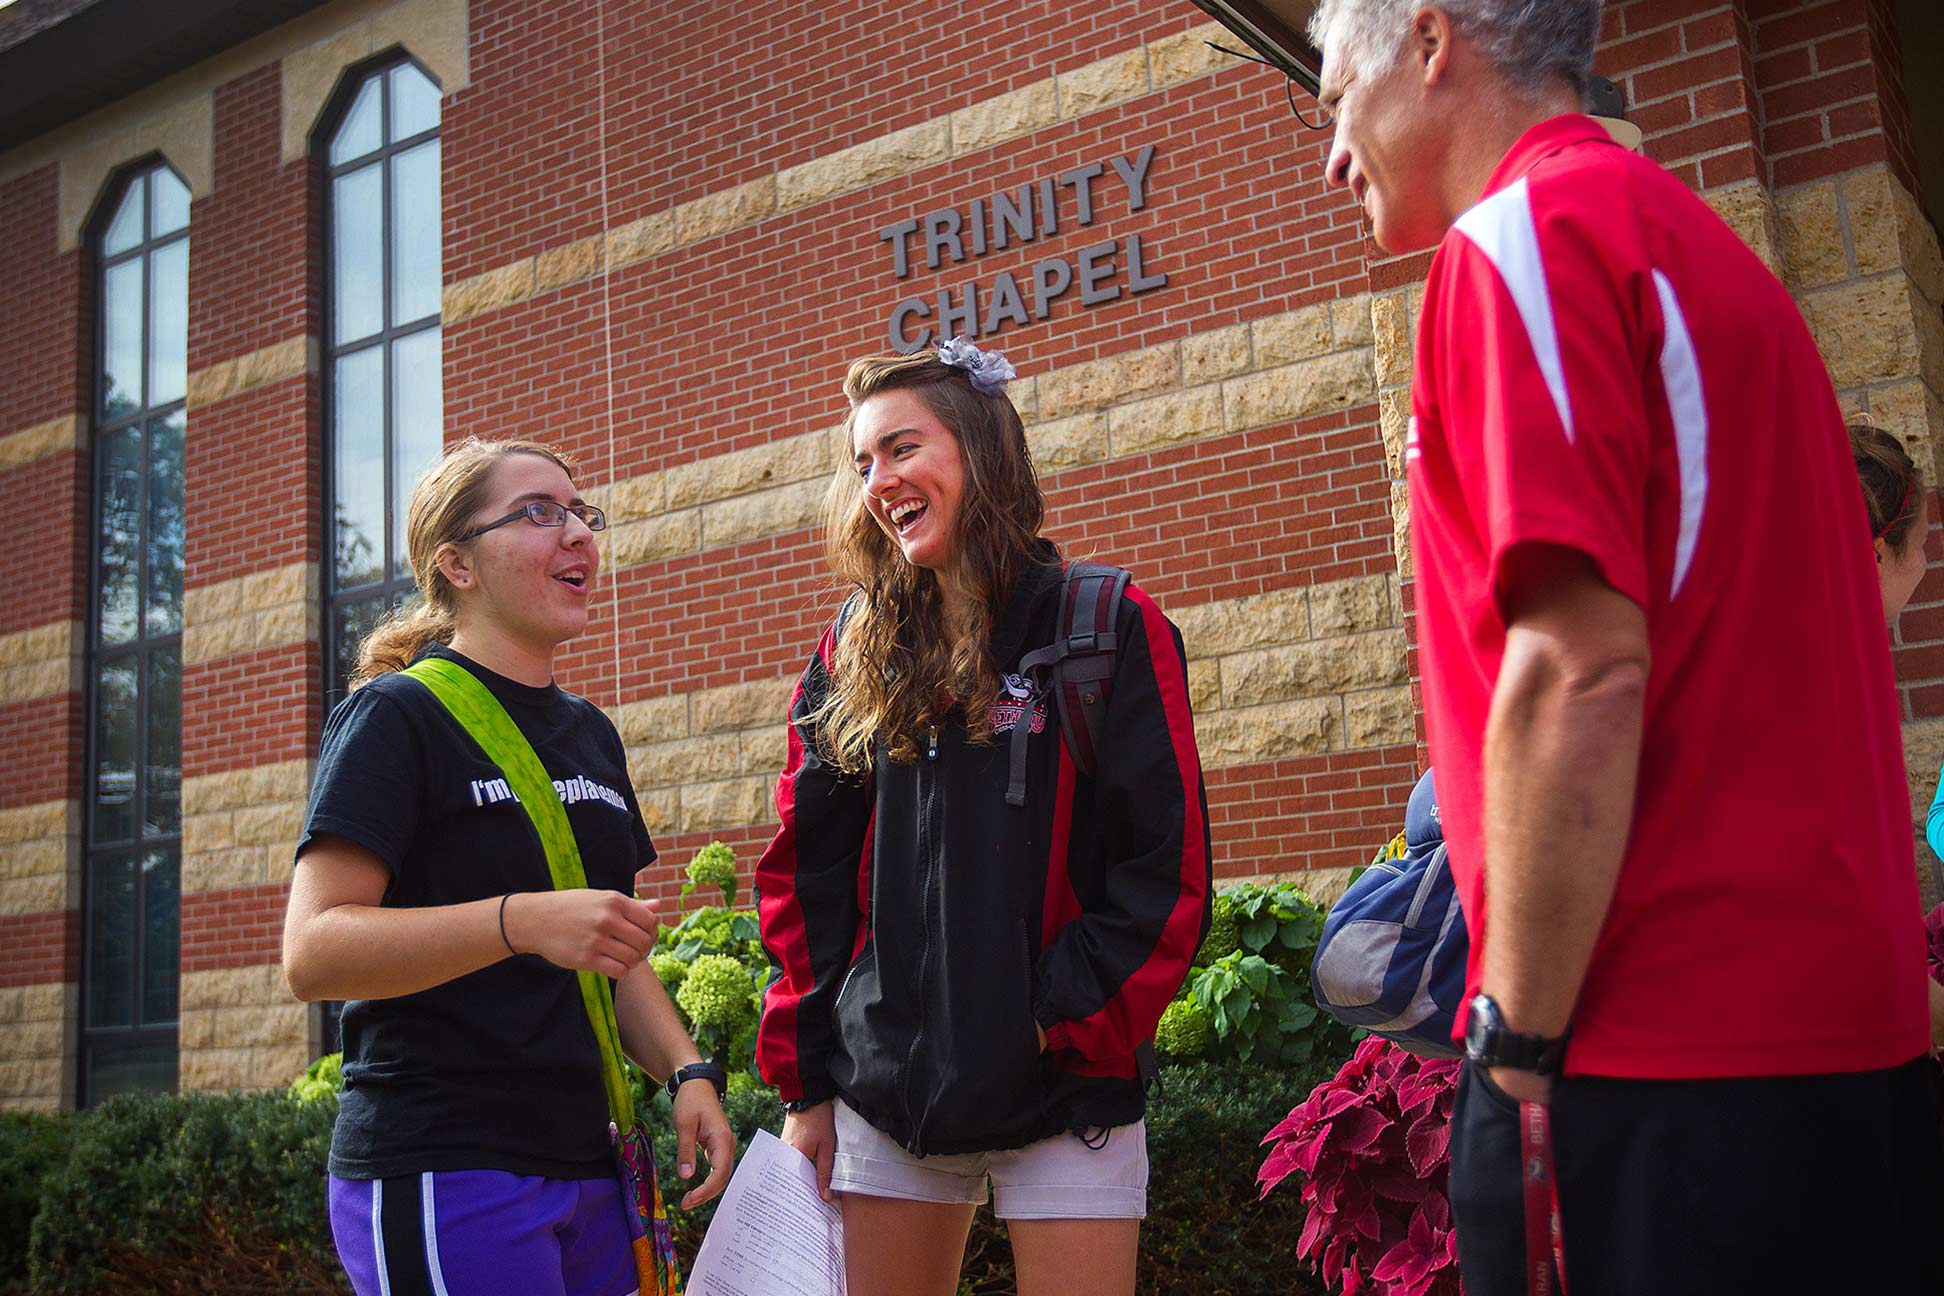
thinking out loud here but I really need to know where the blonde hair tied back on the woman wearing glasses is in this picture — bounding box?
[350,437,573,688]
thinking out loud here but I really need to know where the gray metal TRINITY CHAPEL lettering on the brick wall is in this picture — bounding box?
[877,144,1168,356]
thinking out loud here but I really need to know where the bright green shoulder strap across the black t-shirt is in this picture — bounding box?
[402,657,634,1131]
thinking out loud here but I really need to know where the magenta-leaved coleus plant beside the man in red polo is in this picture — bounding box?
[1256,1036,1464,1296]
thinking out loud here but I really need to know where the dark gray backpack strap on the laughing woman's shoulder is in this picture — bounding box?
[1005,562,1128,806]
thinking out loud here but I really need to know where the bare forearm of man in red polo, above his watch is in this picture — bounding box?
[1481,633,1647,1036]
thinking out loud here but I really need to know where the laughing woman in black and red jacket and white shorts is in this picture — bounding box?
[756,340,1209,1296]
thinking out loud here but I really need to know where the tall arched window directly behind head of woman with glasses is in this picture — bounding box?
[321,56,443,709]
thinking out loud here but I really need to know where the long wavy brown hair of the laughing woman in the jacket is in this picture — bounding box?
[815,350,1046,773]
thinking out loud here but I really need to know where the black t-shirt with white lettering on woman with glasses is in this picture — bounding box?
[297,647,655,1179]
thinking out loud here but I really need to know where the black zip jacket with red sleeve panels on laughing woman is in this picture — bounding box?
[756,552,1209,1156]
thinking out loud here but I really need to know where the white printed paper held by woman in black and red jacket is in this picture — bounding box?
[688,1129,844,1296]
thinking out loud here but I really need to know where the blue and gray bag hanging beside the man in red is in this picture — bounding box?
[1310,771,1470,1057]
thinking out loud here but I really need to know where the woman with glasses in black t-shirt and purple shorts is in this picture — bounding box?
[284,439,735,1296]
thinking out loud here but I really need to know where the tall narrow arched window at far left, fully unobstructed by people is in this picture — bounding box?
[80,161,189,1104]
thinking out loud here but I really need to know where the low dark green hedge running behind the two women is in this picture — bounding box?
[0,1059,1336,1296]
